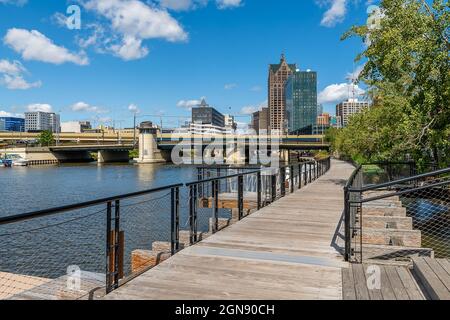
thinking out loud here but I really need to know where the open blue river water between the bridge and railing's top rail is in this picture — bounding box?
[0,163,197,216]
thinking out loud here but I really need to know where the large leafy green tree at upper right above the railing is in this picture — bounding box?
[334,0,450,165]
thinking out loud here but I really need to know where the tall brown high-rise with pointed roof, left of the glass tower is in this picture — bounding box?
[268,54,297,134]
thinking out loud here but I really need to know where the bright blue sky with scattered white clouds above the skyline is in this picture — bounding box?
[0,0,371,127]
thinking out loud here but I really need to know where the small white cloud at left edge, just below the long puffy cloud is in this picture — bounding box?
[0,59,42,90]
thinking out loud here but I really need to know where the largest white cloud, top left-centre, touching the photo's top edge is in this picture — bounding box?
[81,0,188,60]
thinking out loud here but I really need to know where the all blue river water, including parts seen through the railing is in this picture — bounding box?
[0,164,243,284]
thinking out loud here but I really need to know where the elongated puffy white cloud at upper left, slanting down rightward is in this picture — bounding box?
[3,28,89,65]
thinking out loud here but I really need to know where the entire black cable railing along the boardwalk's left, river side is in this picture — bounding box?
[0,158,330,300]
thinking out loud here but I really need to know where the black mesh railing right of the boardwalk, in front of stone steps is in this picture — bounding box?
[344,164,450,263]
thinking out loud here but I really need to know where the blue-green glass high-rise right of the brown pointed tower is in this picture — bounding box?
[286,70,318,134]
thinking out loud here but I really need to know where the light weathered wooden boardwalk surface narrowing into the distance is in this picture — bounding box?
[106,160,354,300]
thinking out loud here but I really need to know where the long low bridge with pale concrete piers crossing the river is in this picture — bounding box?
[0,128,330,164]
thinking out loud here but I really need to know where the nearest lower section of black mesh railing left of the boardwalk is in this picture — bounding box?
[0,184,183,299]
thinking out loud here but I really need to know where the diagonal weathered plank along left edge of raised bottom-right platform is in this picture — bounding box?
[413,258,450,300]
